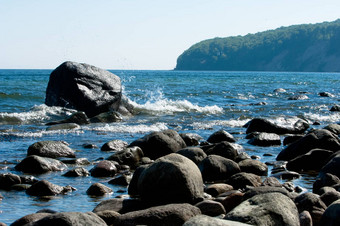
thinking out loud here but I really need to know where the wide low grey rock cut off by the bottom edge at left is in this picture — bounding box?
[23,212,107,226]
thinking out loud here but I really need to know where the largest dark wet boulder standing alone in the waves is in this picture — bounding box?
[45,61,122,117]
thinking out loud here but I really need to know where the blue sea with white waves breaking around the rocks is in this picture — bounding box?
[0,70,340,224]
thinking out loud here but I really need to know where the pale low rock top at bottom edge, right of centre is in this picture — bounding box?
[183,215,249,226]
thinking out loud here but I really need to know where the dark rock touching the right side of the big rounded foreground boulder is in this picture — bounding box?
[198,155,241,182]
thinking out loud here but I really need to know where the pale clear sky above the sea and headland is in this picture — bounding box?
[0,0,340,70]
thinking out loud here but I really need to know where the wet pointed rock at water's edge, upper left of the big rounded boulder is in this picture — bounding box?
[107,146,144,169]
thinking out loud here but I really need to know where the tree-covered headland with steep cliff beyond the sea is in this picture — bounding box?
[175,19,340,72]
